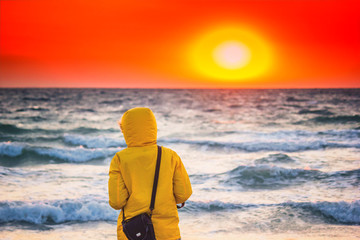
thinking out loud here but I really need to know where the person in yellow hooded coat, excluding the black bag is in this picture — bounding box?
[108,107,192,240]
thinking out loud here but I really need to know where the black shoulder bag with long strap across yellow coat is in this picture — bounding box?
[122,146,161,240]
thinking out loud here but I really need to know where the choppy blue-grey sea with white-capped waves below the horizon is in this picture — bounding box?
[0,88,360,240]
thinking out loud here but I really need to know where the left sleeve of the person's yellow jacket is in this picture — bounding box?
[108,154,129,210]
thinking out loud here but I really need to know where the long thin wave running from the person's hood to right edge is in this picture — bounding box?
[158,139,360,152]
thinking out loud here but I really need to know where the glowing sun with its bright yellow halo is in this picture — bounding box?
[187,26,273,82]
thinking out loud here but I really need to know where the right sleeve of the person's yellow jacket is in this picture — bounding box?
[173,153,192,203]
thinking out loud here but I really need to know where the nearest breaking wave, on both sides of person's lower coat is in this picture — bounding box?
[0,196,360,225]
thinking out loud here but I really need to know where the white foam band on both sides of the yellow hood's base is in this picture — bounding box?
[63,129,360,152]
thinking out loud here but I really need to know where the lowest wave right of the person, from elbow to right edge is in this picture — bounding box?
[187,200,360,225]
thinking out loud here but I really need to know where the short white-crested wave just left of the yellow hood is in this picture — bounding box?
[64,134,126,148]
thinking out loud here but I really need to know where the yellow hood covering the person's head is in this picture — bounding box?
[120,107,157,147]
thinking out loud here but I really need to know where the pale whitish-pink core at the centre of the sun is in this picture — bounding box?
[213,41,251,69]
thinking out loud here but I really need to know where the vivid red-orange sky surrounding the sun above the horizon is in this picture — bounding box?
[0,0,360,88]
